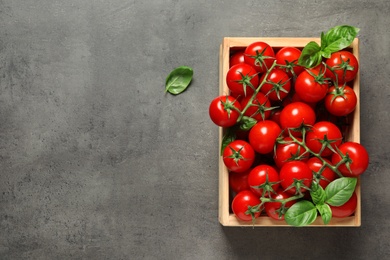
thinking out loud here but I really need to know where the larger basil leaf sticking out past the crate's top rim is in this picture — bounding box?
[321,25,360,54]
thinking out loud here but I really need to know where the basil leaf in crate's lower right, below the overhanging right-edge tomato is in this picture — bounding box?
[325,177,357,207]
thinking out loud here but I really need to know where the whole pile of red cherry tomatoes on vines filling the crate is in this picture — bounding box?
[209,42,369,224]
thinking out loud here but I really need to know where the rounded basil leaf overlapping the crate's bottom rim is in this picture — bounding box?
[284,200,317,227]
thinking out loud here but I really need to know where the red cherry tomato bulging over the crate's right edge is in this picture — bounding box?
[332,142,369,177]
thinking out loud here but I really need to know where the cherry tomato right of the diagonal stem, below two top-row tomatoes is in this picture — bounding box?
[260,69,291,101]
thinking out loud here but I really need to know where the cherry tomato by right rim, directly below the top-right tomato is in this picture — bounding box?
[325,86,357,116]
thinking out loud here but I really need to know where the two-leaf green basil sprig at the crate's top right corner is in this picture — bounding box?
[298,25,360,68]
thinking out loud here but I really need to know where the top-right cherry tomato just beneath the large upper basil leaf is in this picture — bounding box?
[326,51,359,85]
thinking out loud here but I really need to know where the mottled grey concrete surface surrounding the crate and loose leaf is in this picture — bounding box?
[0,0,390,259]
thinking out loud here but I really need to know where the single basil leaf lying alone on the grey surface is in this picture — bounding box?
[165,66,194,95]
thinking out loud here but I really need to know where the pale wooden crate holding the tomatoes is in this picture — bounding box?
[219,37,361,227]
